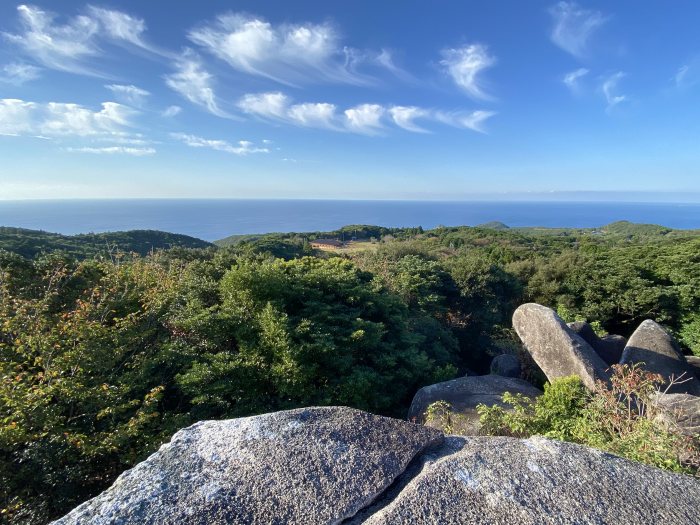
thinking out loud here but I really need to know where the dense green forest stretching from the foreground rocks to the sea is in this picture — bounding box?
[0,223,700,524]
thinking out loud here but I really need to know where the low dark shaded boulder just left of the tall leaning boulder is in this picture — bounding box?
[408,375,542,435]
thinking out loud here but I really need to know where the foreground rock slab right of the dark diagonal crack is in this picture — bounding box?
[364,437,700,525]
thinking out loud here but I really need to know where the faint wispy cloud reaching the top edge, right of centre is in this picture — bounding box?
[550,2,607,58]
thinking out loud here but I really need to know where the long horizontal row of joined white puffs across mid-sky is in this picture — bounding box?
[238,91,496,135]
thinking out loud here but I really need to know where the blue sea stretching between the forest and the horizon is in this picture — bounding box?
[0,199,700,241]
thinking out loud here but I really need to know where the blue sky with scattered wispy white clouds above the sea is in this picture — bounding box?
[0,0,700,201]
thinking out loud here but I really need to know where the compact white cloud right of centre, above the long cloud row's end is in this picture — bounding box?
[440,44,496,100]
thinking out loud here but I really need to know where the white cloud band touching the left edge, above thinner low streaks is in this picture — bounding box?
[0,99,136,137]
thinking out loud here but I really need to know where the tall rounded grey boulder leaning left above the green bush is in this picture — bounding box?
[513,303,609,389]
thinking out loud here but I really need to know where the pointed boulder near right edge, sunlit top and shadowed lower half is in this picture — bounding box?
[620,319,700,396]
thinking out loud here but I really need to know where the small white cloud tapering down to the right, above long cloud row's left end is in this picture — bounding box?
[165,51,231,118]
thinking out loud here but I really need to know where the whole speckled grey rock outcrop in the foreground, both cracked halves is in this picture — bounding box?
[54,407,700,525]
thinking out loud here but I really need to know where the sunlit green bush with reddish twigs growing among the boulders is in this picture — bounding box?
[477,365,700,476]
